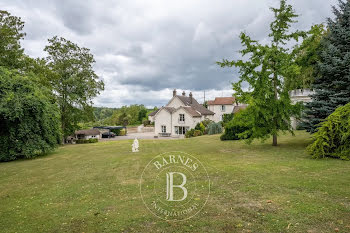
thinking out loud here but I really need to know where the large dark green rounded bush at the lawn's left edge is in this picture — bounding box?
[0,66,61,161]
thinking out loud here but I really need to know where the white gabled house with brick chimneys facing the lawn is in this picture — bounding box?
[149,89,215,136]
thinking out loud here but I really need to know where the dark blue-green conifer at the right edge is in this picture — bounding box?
[303,1,350,133]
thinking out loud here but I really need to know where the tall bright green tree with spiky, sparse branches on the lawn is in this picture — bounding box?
[218,0,305,146]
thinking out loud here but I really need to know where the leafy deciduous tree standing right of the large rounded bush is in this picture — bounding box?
[44,36,104,141]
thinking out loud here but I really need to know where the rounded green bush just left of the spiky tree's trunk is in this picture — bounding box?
[220,110,252,141]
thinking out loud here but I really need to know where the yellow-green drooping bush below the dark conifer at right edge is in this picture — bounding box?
[307,103,350,160]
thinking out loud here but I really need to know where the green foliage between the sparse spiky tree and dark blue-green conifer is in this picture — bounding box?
[286,24,326,90]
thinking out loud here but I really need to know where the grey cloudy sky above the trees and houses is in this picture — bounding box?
[0,0,337,107]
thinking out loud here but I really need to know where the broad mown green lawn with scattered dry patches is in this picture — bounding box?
[0,132,350,233]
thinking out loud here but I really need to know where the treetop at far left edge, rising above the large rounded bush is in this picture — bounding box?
[0,10,25,69]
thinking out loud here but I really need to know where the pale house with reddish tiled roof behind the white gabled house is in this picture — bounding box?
[208,97,247,122]
